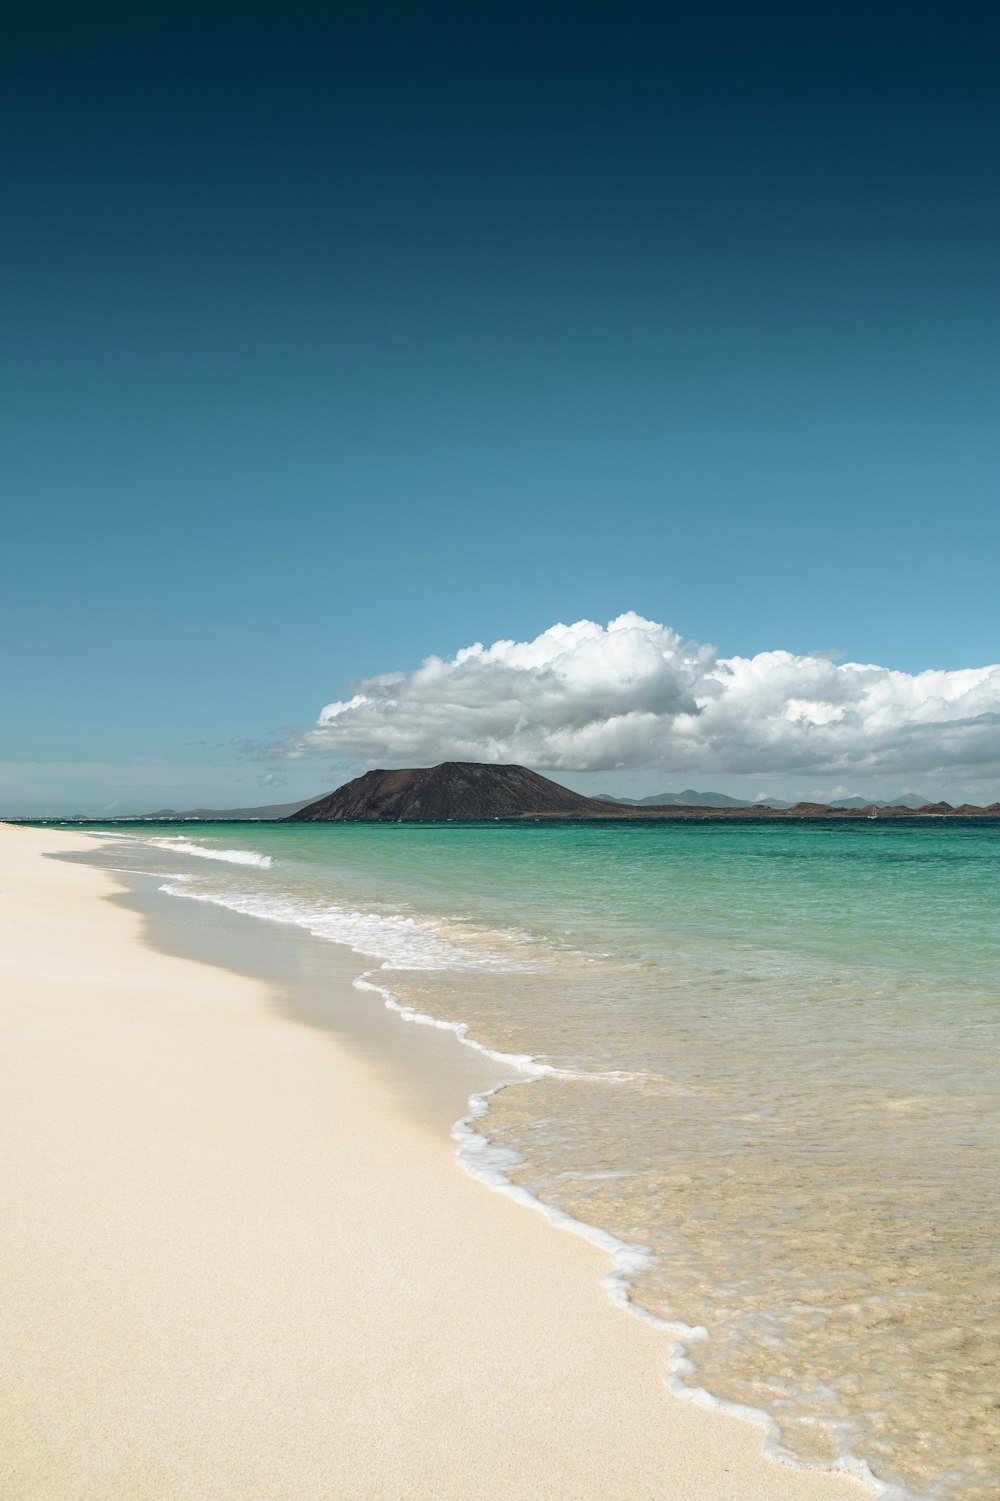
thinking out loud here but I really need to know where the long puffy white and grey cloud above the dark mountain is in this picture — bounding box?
[282,612,1000,778]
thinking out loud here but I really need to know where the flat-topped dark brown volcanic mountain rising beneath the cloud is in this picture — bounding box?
[291,761,614,823]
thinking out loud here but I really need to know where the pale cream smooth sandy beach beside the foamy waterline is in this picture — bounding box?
[0,826,871,1501]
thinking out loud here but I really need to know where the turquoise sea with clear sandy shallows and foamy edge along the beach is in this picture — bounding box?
[72,821,1000,1501]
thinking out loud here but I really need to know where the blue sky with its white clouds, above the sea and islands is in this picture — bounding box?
[0,0,1000,815]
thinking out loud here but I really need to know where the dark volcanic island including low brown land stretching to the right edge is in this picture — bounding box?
[287,761,1000,823]
